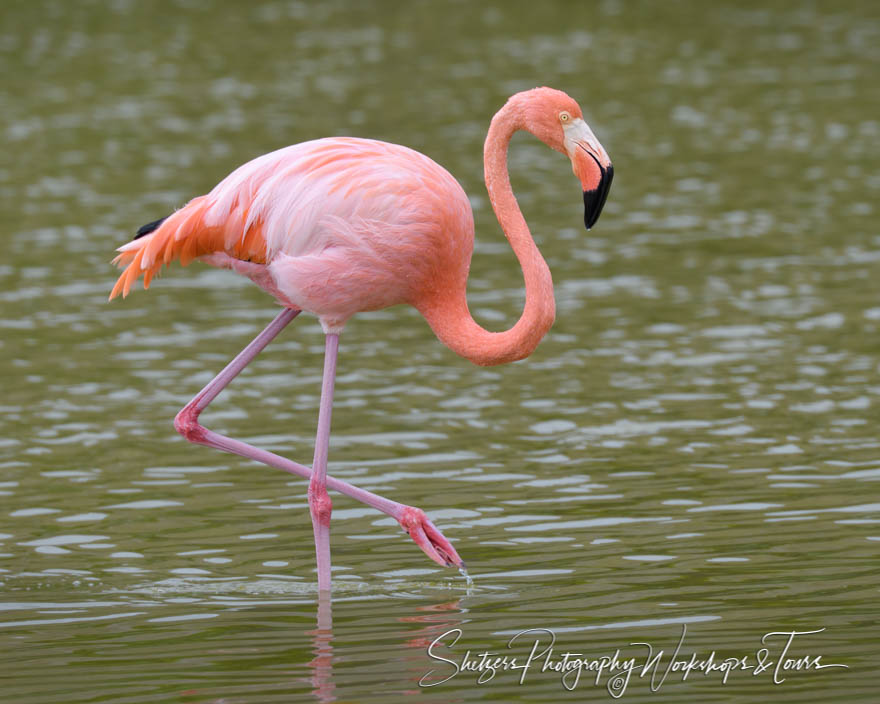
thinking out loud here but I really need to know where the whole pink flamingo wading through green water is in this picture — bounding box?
[110,87,614,593]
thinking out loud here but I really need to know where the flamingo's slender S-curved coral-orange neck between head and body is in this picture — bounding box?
[420,101,556,366]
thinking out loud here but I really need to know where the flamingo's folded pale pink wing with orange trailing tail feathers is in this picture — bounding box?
[110,137,473,299]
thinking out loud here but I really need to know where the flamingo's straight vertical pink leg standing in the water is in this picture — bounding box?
[309,333,339,591]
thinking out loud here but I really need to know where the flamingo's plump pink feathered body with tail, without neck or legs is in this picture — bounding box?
[114,137,474,332]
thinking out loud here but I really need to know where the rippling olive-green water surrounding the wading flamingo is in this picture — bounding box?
[0,0,880,704]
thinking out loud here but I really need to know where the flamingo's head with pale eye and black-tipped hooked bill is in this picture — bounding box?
[511,88,614,230]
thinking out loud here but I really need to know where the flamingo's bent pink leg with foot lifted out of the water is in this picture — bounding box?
[168,308,464,588]
